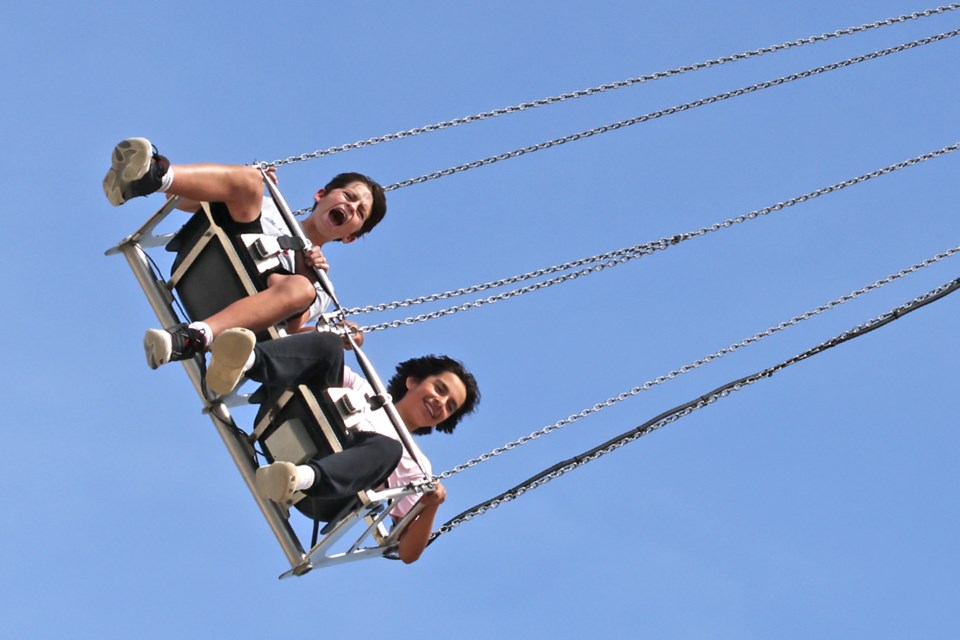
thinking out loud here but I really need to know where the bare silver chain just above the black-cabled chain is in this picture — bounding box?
[437,246,960,480]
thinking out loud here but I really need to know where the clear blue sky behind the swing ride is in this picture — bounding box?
[0,0,960,638]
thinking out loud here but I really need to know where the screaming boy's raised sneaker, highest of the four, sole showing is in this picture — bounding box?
[103,138,170,207]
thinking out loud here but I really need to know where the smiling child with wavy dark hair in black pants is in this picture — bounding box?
[207,329,480,564]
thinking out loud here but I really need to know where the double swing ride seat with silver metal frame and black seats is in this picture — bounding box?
[106,192,416,578]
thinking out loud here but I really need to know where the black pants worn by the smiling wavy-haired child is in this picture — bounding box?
[247,331,403,519]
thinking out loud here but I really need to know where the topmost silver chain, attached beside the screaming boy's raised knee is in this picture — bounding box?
[269,3,960,166]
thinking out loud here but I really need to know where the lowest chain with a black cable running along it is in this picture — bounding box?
[431,278,960,542]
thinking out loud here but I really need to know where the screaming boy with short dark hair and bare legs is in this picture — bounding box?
[103,138,387,369]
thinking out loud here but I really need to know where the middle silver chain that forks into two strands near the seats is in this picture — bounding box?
[360,142,960,333]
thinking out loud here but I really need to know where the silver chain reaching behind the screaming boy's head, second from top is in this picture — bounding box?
[384,29,960,191]
